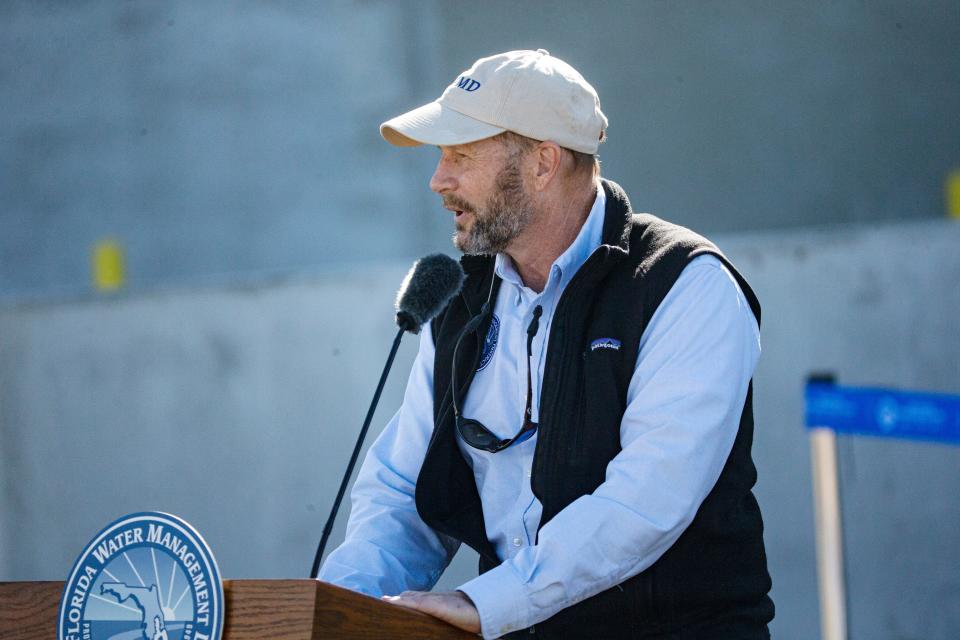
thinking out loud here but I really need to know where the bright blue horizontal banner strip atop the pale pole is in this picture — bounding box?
[805,382,960,444]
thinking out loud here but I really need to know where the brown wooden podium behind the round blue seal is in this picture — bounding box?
[0,580,477,640]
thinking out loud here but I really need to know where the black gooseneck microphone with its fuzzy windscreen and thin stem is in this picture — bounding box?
[310,253,466,579]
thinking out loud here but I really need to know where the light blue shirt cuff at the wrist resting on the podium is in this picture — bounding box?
[457,563,532,639]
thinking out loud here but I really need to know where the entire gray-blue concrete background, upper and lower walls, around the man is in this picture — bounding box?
[0,0,960,640]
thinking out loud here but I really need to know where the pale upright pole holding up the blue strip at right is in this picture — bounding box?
[810,427,847,640]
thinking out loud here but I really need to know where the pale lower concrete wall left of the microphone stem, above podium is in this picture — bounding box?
[0,265,415,580]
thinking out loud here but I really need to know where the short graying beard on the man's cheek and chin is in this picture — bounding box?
[453,157,533,255]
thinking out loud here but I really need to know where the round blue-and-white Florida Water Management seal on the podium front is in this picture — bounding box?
[57,512,223,640]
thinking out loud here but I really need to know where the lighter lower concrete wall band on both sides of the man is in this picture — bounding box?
[0,222,960,640]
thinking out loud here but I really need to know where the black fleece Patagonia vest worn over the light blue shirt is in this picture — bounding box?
[416,180,773,640]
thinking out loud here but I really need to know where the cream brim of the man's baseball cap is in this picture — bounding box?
[380,102,506,147]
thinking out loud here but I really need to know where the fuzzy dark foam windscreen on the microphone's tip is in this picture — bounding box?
[396,253,466,333]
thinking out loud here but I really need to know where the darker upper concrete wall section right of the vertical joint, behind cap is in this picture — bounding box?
[440,0,960,232]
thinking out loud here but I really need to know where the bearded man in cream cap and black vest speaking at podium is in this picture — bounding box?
[320,49,774,640]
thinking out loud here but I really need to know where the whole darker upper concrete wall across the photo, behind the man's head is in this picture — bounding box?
[0,0,960,299]
